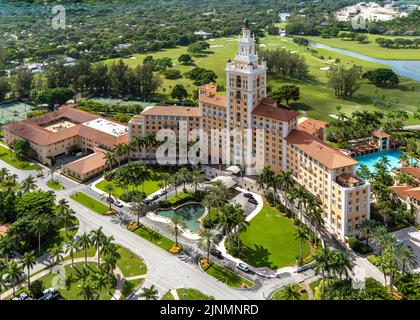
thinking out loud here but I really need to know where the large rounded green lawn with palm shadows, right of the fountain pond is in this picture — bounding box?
[241,204,309,269]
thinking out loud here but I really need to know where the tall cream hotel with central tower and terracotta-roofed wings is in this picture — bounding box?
[129,23,370,238]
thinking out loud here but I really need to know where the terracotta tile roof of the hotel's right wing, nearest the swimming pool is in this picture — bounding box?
[286,129,358,169]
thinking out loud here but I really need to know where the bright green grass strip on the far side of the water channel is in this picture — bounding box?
[305,34,420,60]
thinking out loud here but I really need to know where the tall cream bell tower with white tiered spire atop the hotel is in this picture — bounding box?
[226,19,267,174]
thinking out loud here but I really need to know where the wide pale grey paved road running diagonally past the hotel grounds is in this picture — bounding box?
[2,163,310,300]
